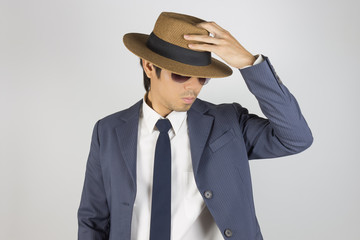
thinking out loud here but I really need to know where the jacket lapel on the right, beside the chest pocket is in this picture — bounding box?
[188,99,214,174]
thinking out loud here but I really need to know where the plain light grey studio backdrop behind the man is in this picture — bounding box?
[0,0,360,240]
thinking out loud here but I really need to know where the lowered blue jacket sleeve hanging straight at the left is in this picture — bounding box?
[78,121,110,240]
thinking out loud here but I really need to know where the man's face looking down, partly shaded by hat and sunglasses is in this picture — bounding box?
[148,62,203,117]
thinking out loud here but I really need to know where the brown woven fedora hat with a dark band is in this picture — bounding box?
[123,12,232,78]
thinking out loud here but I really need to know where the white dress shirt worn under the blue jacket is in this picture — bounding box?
[131,55,263,240]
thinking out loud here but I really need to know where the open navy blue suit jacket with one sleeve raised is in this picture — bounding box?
[78,57,313,240]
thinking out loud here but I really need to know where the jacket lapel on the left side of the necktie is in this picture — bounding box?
[116,100,142,189]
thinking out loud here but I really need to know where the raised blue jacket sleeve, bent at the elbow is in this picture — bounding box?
[233,56,313,159]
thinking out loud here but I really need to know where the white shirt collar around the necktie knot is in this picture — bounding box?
[142,94,187,135]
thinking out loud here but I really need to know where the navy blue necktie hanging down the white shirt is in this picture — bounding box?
[150,119,171,240]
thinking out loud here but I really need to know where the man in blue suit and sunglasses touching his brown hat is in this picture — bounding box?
[78,12,313,240]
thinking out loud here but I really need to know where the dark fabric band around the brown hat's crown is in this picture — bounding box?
[146,32,211,66]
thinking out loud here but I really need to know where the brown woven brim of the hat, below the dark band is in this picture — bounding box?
[123,33,232,78]
